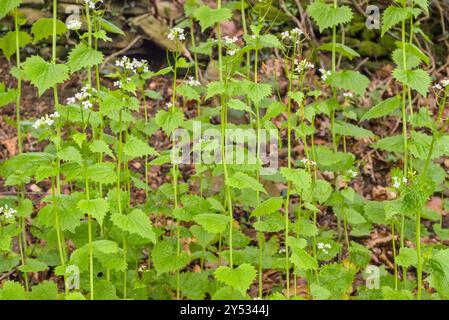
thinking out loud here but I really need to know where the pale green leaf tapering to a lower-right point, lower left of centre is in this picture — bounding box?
[111,209,156,243]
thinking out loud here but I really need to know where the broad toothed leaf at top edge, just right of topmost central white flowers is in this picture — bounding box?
[307,0,352,32]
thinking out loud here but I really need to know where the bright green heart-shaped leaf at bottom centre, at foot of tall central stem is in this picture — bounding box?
[214,263,257,294]
